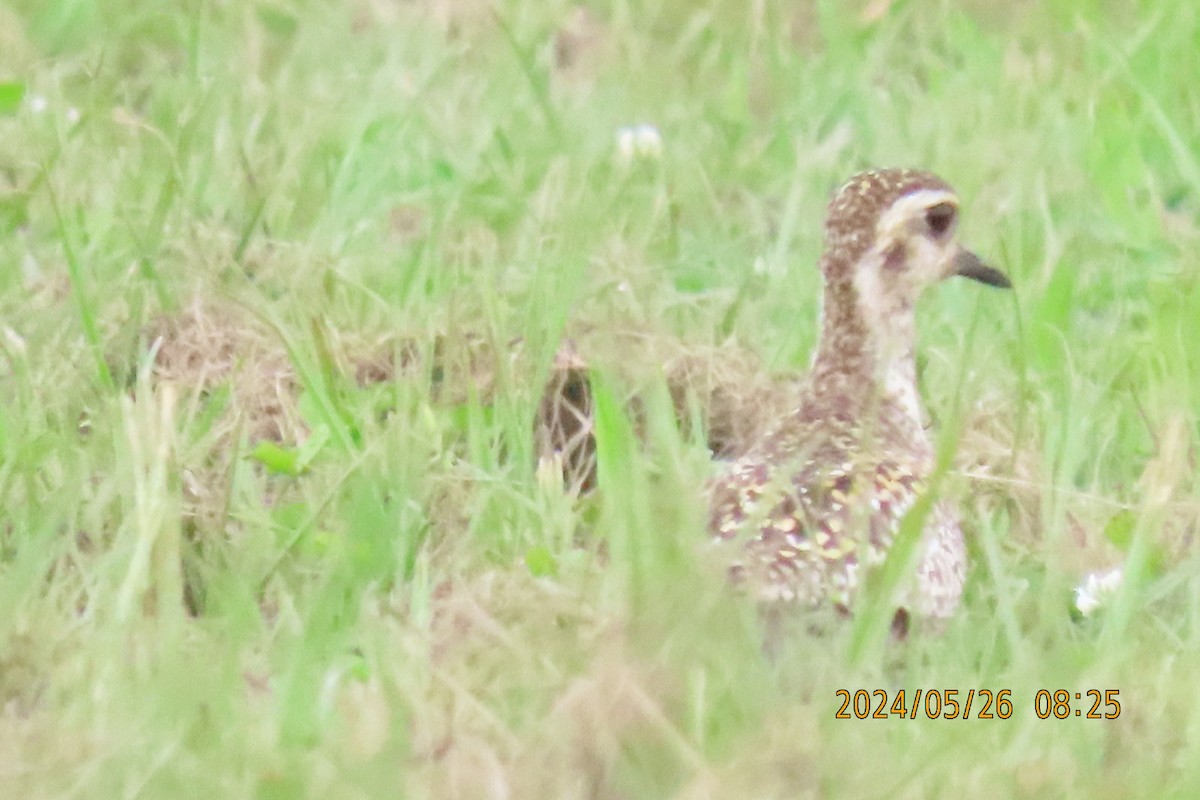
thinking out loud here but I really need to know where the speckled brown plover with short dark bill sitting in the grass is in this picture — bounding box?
[709,169,1008,618]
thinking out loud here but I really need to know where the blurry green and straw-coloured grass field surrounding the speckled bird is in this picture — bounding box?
[0,0,1200,800]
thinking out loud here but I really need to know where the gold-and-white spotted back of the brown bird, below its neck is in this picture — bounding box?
[709,398,931,607]
